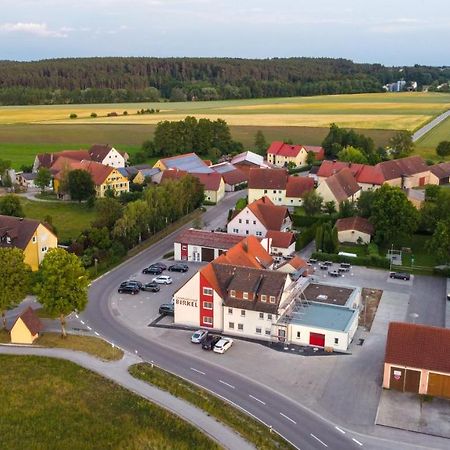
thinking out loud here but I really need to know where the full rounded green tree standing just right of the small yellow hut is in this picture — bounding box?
[35,248,89,337]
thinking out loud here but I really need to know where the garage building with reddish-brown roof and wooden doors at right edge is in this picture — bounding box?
[383,322,450,398]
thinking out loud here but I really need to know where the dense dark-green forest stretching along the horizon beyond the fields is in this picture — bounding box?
[0,57,450,105]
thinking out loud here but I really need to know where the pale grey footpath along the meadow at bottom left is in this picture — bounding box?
[0,345,254,450]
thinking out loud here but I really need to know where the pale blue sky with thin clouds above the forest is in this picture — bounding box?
[0,0,450,66]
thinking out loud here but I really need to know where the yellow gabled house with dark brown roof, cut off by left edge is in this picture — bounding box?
[0,215,58,271]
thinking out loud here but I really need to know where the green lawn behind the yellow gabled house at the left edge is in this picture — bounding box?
[21,198,96,242]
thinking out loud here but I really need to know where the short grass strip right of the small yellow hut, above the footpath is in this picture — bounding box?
[35,333,123,361]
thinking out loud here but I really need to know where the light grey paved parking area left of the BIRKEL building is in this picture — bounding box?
[110,259,205,328]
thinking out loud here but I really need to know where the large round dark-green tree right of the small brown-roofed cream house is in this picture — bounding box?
[370,184,419,244]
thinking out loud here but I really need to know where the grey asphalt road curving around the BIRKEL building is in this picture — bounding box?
[81,191,380,450]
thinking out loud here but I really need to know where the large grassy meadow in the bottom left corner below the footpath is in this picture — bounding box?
[0,355,219,450]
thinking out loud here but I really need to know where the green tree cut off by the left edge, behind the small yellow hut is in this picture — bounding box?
[0,248,31,328]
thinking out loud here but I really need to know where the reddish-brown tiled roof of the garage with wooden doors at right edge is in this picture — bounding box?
[385,322,450,374]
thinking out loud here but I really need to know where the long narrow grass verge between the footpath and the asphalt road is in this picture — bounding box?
[129,363,292,450]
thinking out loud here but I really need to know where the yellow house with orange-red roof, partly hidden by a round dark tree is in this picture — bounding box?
[53,160,130,198]
